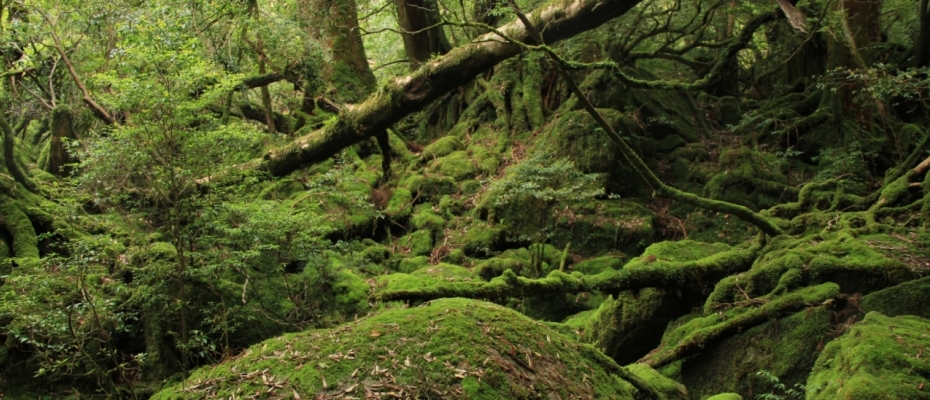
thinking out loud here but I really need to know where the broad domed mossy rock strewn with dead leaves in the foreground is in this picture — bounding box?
[153,299,633,399]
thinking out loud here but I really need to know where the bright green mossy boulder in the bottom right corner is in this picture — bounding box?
[807,312,930,400]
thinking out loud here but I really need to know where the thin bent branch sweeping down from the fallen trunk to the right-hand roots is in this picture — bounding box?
[511,3,782,236]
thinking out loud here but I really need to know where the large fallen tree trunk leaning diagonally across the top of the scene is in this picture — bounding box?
[261,0,640,176]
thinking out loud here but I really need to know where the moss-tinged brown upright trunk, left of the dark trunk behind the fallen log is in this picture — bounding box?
[297,0,376,103]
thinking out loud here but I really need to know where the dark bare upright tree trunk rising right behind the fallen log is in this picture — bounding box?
[394,0,452,68]
